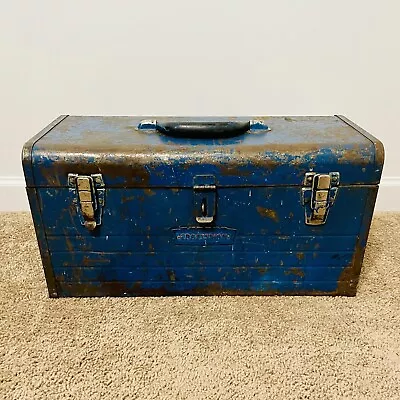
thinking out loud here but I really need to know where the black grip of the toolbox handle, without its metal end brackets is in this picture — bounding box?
[156,121,250,139]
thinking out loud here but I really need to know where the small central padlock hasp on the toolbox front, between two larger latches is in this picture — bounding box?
[193,175,217,224]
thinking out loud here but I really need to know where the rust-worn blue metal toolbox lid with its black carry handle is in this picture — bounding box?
[22,116,384,187]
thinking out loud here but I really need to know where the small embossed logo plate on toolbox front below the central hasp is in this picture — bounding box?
[172,228,236,246]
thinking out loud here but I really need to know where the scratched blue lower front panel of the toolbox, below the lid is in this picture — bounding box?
[37,186,376,296]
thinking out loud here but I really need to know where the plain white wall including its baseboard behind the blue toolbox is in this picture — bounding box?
[0,0,400,210]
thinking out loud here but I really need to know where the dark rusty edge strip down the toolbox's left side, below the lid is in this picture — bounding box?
[26,187,58,297]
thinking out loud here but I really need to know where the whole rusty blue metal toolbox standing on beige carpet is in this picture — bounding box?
[22,116,384,297]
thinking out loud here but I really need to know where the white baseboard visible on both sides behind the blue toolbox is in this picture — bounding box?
[0,176,400,211]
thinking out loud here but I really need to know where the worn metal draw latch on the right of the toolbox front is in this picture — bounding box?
[301,172,340,225]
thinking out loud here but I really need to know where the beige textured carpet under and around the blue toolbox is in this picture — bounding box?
[0,213,400,400]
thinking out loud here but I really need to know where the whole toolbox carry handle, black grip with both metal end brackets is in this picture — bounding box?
[138,120,269,139]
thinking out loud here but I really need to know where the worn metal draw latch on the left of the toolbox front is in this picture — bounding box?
[68,174,105,231]
